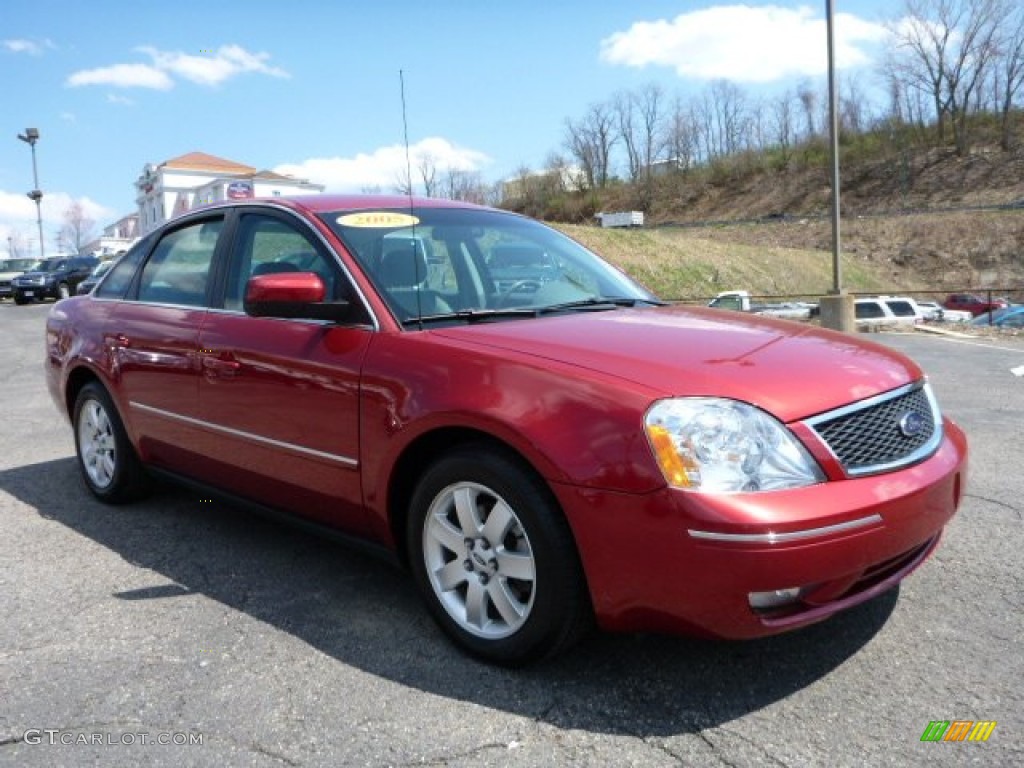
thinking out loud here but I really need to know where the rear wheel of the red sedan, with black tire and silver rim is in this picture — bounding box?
[72,382,150,504]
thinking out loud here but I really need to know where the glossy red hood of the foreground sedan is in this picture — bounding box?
[434,307,923,422]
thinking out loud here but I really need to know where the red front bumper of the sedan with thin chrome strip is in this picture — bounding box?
[555,421,967,639]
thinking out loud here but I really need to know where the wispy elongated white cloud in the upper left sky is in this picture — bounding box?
[68,45,290,91]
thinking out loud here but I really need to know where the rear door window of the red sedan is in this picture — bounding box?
[138,219,223,306]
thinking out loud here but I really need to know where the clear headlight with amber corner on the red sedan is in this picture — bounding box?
[644,397,824,493]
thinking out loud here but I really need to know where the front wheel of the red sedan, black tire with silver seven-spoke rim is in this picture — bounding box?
[407,444,592,667]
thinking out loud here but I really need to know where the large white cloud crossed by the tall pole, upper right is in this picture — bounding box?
[601,5,887,83]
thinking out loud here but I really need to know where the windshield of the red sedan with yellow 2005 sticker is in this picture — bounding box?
[321,208,656,322]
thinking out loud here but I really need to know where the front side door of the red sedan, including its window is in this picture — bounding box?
[199,207,374,532]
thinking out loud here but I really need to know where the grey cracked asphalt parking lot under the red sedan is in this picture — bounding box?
[0,301,1024,768]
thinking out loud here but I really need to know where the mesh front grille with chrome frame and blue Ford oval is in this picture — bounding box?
[807,385,942,476]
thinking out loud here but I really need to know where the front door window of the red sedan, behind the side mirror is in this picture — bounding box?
[224,213,342,309]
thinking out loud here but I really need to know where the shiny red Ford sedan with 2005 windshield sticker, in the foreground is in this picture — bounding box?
[46,196,967,665]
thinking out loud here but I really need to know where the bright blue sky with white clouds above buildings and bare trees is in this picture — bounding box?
[0,0,895,255]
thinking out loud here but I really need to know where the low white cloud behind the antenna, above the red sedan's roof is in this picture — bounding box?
[273,137,490,193]
